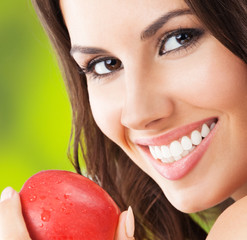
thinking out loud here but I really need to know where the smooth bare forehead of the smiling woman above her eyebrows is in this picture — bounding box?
[60,0,187,45]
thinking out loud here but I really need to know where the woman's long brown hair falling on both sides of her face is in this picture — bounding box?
[33,0,247,240]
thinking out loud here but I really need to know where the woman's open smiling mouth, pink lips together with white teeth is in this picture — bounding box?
[136,118,219,180]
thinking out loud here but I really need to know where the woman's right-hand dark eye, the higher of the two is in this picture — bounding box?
[160,29,204,55]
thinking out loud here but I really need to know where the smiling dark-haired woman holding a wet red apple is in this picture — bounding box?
[0,0,247,240]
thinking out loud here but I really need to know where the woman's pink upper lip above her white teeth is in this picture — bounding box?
[134,117,217,146]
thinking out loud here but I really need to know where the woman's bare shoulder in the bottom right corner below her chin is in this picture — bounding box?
[207,196,247,240]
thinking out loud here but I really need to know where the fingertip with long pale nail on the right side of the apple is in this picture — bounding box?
[115,207,135,240]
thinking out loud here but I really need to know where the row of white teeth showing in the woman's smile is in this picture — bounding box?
[149,122,215,163]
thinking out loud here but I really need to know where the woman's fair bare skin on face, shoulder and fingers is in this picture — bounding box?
[0,0,247,240]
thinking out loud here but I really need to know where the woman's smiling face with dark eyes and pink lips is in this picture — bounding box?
[61,0,247,212]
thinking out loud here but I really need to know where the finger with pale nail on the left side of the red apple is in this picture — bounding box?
[0,187,31,240]
